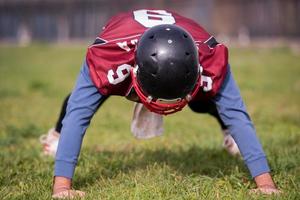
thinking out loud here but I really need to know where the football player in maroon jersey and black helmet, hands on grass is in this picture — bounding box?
[46,9,279,198]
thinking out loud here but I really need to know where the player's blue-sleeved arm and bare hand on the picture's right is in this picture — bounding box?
[214,68,278,193]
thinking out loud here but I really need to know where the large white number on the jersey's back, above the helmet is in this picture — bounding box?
[133,10,175,28]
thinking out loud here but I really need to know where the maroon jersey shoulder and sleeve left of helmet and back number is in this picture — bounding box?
[86,12,145,96]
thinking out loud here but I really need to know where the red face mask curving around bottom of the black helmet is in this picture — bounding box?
[130,65,201,115]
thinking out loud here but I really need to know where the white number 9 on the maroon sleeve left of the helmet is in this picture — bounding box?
[107,64,131,85]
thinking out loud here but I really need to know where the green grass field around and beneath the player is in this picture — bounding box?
[0,45,300,200]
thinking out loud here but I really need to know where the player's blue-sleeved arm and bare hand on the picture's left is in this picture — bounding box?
[53,62,106,197]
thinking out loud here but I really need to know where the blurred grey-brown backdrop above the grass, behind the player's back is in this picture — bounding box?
[0,0,300,45]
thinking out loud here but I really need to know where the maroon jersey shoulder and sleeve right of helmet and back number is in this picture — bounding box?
[175,14,228,99]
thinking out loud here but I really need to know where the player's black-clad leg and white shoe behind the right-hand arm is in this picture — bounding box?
[189,100,240,155]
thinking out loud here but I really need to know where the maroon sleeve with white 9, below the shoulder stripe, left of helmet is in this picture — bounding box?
[86,43,134,96]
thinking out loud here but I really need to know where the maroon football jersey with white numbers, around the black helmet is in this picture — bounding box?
[87,9,228,99]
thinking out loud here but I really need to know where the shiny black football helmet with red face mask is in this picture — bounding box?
[131,24,200,114]
